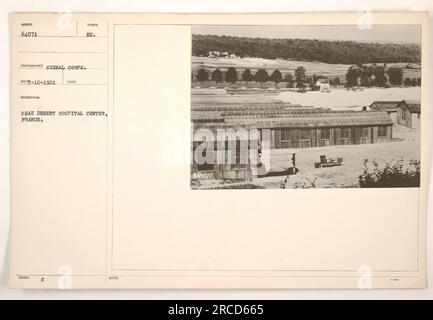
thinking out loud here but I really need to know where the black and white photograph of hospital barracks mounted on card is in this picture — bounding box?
[190,24,421,190]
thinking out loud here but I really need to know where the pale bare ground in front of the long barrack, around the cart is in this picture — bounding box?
[254,126,420,188]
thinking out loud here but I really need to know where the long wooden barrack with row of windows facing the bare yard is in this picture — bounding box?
[191,103,393,149]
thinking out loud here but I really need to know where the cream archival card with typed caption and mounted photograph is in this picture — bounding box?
[9,12,431,289]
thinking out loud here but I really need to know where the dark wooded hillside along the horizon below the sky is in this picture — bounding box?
[192,34,421,64]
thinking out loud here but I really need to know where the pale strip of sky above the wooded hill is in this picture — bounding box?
[192,25,421,44]
